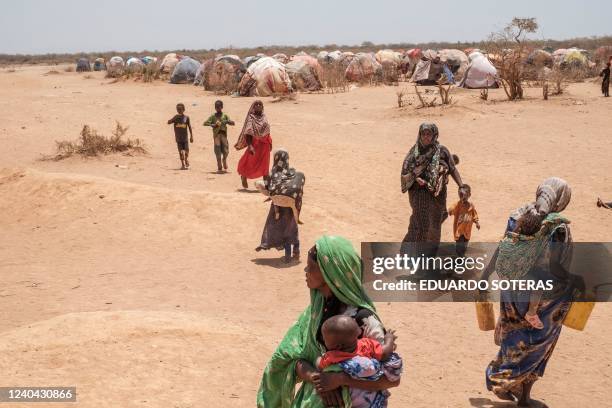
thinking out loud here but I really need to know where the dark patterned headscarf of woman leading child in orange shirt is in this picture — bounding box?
[401,123,440,195]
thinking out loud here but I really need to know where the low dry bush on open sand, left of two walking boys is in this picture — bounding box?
[45,122,147,160]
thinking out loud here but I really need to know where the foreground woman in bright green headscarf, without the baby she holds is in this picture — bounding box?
[257,236,400,408]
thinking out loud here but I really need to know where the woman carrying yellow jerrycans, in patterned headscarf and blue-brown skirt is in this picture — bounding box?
[483,177,578,407]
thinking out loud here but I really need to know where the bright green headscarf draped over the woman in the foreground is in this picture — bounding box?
[257,236,378,408]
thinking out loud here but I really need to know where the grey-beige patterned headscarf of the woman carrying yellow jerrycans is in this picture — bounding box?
[510,177,572,220]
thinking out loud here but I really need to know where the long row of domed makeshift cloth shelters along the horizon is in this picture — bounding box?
[77,47,612,96]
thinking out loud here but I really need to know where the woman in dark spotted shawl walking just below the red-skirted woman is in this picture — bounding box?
[255,148,306,262]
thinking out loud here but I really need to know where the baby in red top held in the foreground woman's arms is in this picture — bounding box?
[313,315,401,408]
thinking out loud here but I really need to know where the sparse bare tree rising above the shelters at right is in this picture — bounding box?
[488,17,538,101]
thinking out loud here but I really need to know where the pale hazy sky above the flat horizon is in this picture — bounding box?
[0,0,612,54]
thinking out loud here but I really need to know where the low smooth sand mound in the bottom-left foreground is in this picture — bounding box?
[0,311,261,407]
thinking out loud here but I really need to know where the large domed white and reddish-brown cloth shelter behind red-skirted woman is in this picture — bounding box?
[238,57,291,96]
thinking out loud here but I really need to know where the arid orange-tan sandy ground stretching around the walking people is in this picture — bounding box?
[0,67,612,408]
